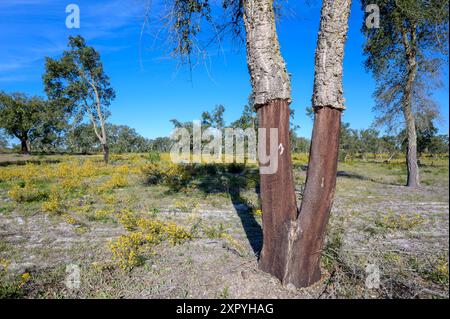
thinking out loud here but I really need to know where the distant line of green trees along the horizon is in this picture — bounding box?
[0,89,449,161]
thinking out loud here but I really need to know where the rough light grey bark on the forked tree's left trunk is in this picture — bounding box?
[243,0,291,108]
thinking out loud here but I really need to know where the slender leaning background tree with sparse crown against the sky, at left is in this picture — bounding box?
[43,36,115,163]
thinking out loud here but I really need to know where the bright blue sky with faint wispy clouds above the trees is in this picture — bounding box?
[0,0,449,138]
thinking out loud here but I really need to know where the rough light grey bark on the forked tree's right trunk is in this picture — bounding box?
[312,0,351,110]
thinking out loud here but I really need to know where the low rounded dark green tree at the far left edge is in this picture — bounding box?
[0,92,65,154]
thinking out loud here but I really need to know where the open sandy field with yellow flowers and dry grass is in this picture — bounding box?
[0,154,449,298]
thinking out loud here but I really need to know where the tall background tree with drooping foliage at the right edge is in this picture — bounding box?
[362,0,449,187]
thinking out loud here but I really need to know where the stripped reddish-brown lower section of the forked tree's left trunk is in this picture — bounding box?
[258,99,297,279]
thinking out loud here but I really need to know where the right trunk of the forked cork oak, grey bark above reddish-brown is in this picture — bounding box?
[283,0,351,287]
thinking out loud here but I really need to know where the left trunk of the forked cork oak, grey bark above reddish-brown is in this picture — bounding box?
[243,0,297,279]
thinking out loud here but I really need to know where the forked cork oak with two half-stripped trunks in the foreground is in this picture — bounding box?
[244,0,351,287]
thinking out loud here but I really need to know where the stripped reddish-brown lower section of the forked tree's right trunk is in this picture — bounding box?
[283,107,341,287]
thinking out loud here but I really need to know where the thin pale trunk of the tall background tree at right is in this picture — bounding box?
[402,25,420,187]
